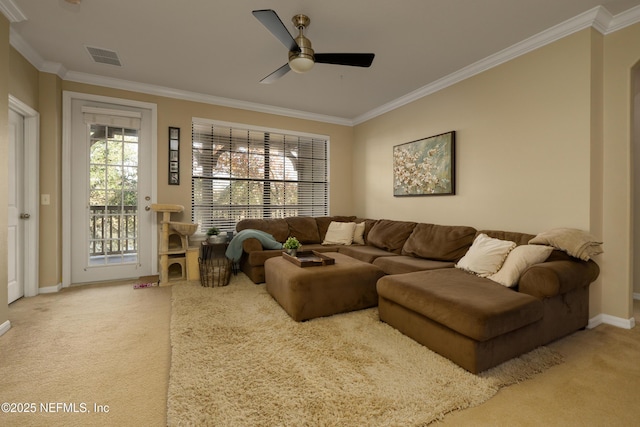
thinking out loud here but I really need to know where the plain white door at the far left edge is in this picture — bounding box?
[7,110,28,303]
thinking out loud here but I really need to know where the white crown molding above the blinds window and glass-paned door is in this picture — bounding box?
[63,71,353,126]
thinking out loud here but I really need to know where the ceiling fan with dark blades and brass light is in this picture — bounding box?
[252,9,375,83]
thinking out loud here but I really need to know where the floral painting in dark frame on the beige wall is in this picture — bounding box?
[393,131,456,197]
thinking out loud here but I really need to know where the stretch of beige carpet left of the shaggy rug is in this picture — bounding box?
[0,283,171,427]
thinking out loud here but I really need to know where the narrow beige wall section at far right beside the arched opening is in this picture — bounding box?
[601,24,640,317]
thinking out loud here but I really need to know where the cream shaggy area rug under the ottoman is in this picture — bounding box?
[167,274,562,427]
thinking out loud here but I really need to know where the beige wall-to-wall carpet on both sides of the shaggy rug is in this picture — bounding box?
[0,276,640,427]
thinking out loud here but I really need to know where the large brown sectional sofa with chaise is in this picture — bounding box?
[231,217,599,373]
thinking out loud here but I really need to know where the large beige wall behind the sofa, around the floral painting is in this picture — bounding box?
[354,30,591,233]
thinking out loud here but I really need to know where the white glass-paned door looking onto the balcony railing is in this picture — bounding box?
[70,100,156,283]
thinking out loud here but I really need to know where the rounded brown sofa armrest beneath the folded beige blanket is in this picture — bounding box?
[518,260,600,299]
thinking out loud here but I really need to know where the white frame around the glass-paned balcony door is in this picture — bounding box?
[62,91,158,288]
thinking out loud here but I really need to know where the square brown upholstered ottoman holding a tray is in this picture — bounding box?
[264,252,384,322]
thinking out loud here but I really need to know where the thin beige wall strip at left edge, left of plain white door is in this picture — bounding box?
[0,14,9,326]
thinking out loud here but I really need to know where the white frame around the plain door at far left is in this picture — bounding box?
[9,95,40,297]
